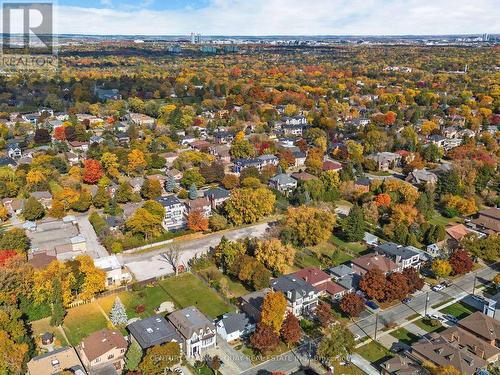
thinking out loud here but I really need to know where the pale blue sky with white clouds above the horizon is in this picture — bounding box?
[0,0,500,36]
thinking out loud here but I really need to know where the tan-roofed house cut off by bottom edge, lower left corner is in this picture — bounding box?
[27,346,87,375]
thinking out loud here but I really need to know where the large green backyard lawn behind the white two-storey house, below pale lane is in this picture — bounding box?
[160,273,234,318]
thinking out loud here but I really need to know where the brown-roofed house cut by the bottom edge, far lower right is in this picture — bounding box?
[411,333,488,375]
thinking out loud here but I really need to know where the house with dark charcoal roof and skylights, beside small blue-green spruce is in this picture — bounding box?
[127,315,183,351]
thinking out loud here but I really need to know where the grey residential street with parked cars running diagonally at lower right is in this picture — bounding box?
[350,264,498,338]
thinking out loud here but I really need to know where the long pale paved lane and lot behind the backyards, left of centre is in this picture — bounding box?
[118,223,269,281]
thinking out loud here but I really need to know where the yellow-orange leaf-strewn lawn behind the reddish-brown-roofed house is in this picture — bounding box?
[63,303,107,346]
